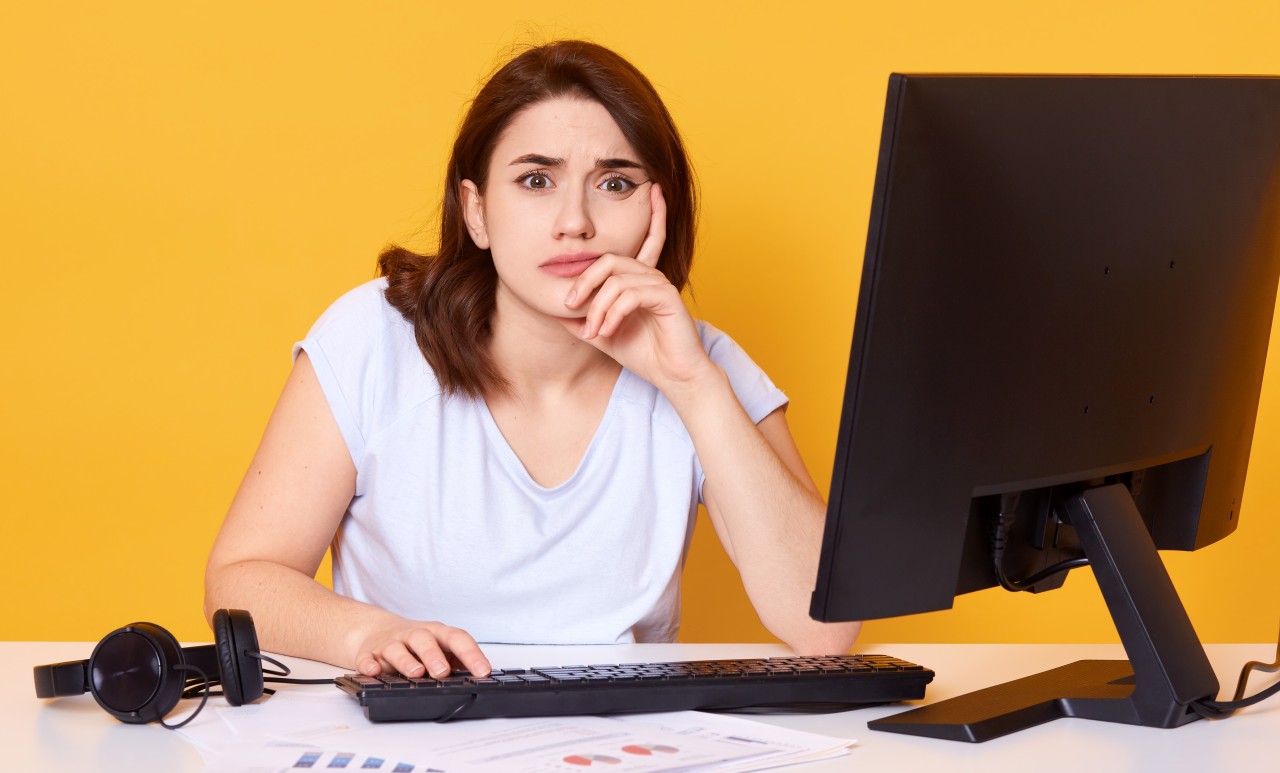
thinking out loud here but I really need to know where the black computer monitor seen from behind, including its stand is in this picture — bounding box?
[810,74,1280,741]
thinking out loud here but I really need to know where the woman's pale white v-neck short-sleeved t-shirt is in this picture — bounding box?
[293,279,787,644]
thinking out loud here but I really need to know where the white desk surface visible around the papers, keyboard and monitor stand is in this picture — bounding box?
[0,642,1280,773]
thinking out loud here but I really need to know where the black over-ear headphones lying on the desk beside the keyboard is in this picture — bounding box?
[35,609,333,728]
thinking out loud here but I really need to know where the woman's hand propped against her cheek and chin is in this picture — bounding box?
[563,183,714,389]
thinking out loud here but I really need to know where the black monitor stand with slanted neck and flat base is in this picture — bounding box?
[867,485,1219,742]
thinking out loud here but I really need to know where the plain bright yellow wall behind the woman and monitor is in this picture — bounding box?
[0,0,1280,642]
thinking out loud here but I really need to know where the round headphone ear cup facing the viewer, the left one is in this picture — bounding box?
[87,623,187,724]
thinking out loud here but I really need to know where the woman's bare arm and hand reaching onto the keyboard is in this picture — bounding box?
[205,353,489,676]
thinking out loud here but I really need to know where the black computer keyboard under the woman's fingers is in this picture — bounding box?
[335,655,933,722]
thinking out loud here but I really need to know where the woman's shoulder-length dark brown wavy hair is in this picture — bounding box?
[378,41,698,398]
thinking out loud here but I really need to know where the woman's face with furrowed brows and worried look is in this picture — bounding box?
[462,97,650,317]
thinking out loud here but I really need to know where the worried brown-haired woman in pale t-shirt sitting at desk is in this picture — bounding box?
[205,41,858,676]
